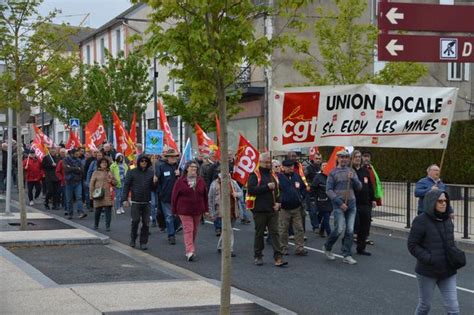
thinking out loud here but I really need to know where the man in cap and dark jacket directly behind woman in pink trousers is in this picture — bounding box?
[155,149,180,245]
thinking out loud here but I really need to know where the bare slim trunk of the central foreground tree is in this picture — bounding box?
[217,78,232,314]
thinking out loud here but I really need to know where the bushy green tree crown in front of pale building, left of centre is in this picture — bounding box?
[47,51,152,131]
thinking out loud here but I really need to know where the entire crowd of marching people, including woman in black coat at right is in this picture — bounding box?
[0,143,465,314]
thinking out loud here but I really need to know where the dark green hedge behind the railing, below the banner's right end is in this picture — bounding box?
[321,120,474,184]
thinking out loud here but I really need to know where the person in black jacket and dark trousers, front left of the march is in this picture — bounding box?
[121,155,157,250]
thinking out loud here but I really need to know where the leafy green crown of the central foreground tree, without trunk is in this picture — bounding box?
[139,0,306,129]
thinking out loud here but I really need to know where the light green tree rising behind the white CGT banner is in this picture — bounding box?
[289,0,428,85]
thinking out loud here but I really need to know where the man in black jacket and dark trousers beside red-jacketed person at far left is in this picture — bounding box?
[41,147,61,210]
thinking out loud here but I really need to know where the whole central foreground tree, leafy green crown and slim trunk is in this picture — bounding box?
[139,0,305,314]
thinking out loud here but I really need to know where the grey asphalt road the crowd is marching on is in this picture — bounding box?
[24,206,474,314]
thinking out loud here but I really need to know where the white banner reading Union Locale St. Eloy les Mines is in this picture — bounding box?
[269,84,457,150]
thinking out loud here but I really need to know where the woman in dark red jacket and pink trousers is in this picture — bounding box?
[171,161,208,261]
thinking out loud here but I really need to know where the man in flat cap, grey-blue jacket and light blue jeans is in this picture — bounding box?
[323,150,362,265]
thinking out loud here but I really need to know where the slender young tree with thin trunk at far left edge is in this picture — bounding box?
[0,0,79,230]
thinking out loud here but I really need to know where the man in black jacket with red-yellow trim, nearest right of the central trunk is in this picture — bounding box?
[247,153,288,267]
